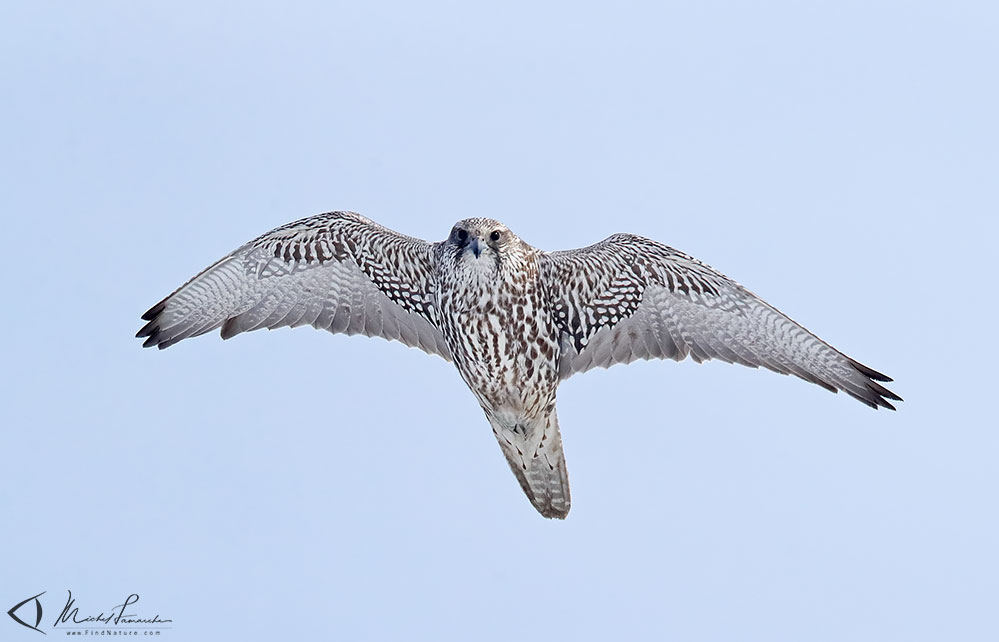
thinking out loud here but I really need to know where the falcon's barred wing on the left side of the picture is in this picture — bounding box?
[136,212,451,360]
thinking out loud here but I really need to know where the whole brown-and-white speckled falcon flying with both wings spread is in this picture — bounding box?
[136,212,901,519]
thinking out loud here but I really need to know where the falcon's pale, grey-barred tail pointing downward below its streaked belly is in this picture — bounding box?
[490,412,569,519]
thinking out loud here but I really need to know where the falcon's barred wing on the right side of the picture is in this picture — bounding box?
[541,234,901,409]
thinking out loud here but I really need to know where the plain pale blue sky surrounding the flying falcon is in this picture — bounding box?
[0,0,999,642]
